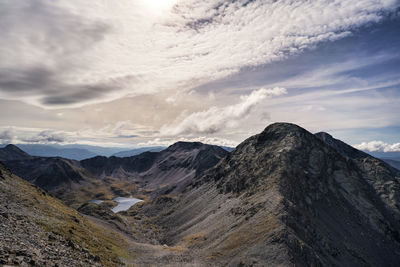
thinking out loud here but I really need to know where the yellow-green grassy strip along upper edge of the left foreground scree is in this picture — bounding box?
[0,166,134,266]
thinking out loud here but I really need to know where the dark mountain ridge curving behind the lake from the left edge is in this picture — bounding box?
[0,142,228,207]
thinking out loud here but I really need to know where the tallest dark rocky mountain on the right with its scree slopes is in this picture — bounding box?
[135,123,400,266]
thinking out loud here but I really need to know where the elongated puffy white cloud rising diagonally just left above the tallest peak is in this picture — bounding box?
[160,87,287,136]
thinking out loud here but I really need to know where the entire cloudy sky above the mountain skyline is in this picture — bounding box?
[0,0,400,152]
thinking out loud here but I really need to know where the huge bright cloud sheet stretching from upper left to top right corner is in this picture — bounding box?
[0,0,399,108]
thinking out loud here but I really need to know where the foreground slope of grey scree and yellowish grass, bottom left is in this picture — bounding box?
[0,163,127,266]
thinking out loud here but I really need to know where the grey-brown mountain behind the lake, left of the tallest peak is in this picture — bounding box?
[81,142,228,195]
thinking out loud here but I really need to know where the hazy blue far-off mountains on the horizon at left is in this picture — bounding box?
[16,144,97,160]
